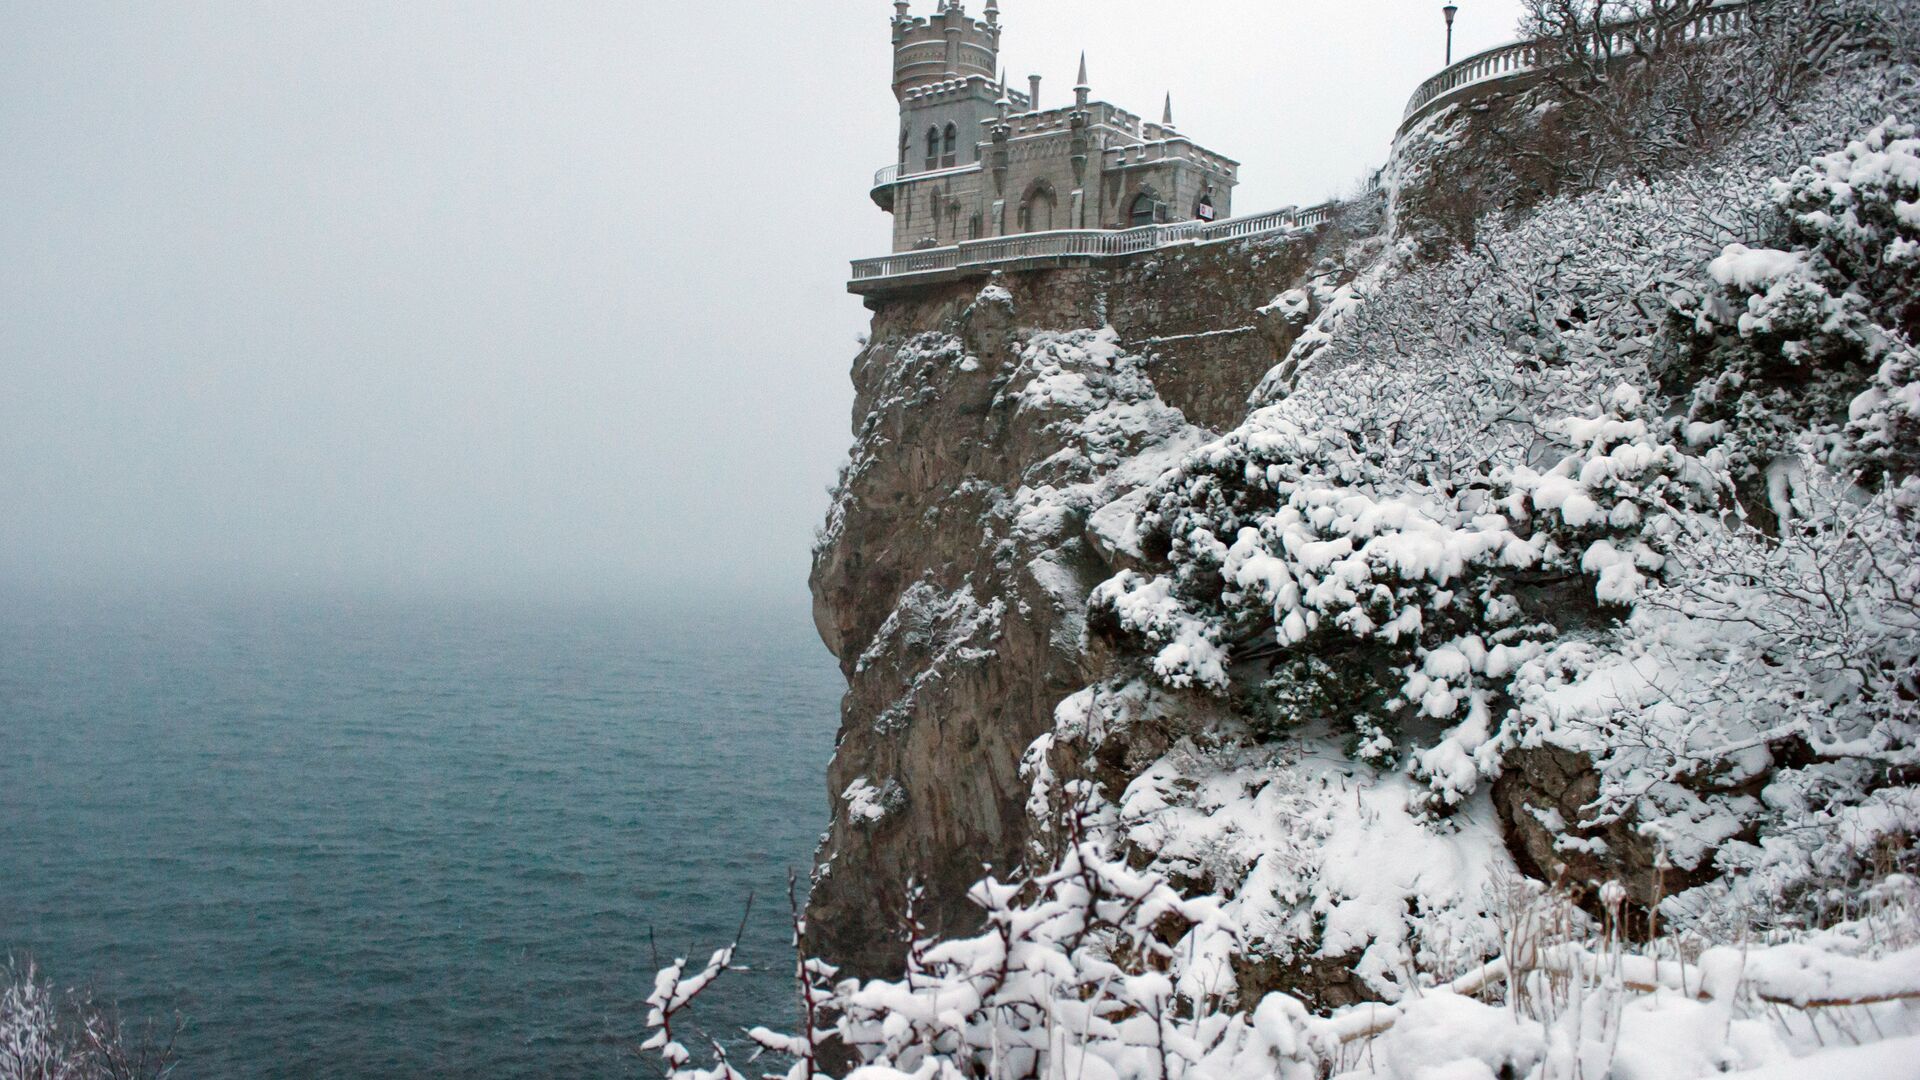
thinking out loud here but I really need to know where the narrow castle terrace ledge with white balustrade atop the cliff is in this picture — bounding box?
[847,202,1338,300]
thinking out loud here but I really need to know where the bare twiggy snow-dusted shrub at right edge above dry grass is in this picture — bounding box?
[1500,461,1920,932]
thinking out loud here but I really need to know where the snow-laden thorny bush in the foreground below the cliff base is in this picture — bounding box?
[645,815,1351,1080]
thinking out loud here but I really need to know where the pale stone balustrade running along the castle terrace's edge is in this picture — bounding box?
[852,202,1338,282]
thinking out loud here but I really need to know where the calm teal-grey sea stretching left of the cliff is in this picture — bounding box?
[0,594,841,1078]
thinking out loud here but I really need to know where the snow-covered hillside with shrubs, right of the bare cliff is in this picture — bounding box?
[653,61,1920,1080]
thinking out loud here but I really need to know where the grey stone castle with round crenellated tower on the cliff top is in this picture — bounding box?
[874,0,1238,252]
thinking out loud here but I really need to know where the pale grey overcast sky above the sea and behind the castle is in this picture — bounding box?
[0,0,1517,600]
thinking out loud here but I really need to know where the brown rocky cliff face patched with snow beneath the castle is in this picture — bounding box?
[810,236,1325,974]
